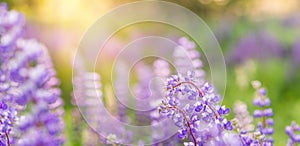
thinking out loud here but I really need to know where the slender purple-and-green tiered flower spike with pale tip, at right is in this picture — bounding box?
[252,81,274,145]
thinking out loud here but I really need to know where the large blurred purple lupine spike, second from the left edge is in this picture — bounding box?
[11,40,64,145]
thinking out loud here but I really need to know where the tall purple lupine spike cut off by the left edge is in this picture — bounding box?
[0,3,24,146]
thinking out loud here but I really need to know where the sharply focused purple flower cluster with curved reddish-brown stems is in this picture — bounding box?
[160,72,242,145]
